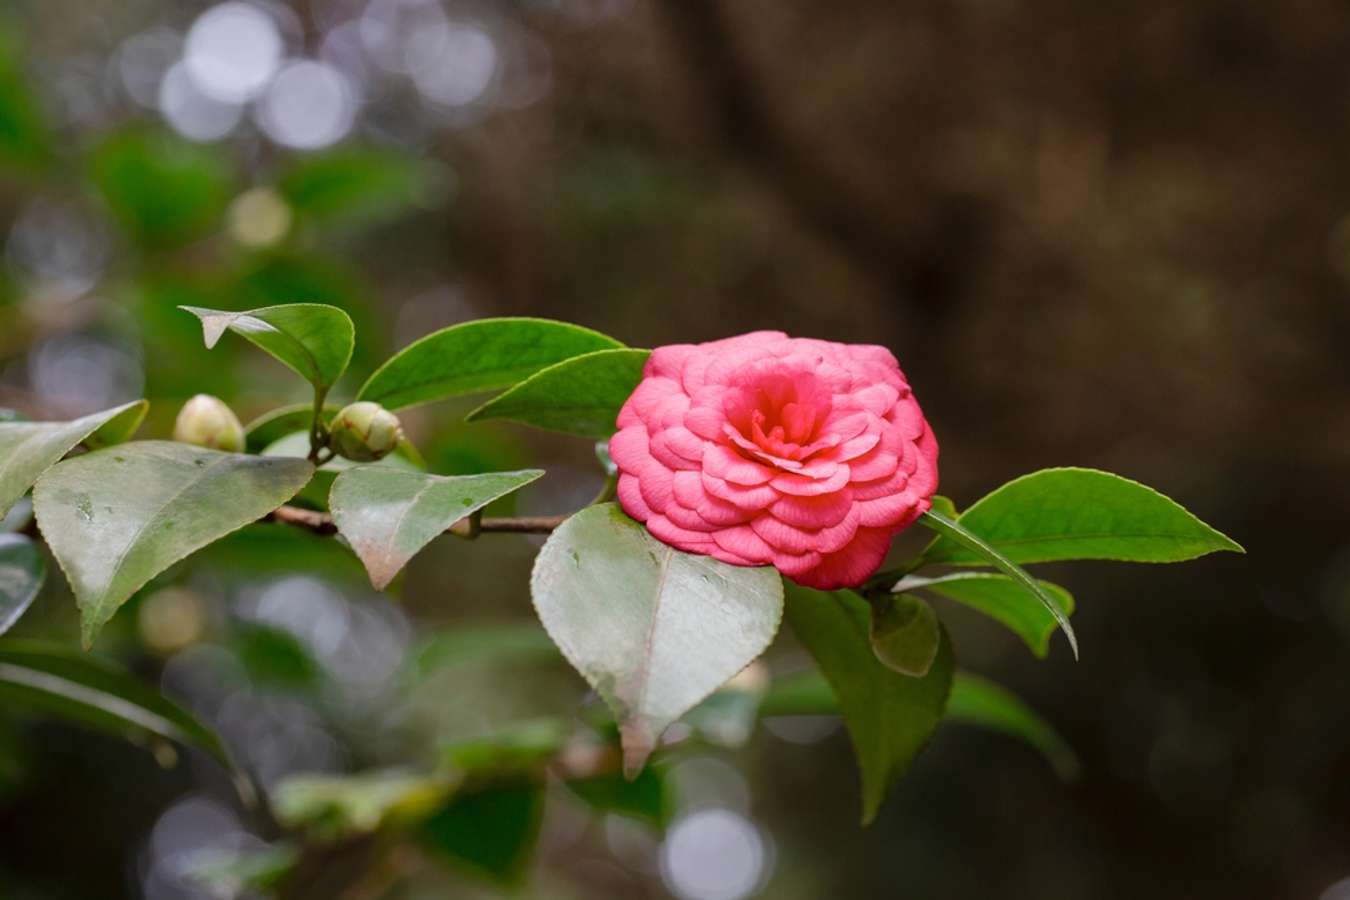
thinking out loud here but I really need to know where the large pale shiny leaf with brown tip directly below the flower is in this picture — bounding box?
[531,503,783,776]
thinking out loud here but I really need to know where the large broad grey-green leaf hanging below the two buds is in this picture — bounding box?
[32,441,315,646]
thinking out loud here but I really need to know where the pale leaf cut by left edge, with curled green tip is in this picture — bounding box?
[0,399,150,514]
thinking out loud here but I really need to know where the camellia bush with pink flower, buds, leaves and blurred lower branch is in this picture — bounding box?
[0,304,1241,896]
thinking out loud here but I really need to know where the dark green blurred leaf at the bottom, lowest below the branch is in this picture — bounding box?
[419,783,544,885]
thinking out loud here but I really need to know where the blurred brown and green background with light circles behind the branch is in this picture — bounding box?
[0,0,1350,900]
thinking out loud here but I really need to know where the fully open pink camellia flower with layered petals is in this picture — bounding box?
[609,332,937,590]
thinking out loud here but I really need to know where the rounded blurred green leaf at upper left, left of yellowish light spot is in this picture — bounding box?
[90,130,234,247]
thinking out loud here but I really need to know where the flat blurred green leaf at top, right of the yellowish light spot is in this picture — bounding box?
[277,146,446,224]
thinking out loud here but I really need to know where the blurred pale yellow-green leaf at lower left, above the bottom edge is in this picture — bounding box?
[271,769,455,841]
